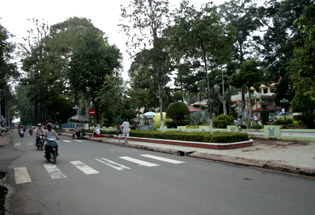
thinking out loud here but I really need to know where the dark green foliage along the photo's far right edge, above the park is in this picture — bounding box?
[288,1,315,113]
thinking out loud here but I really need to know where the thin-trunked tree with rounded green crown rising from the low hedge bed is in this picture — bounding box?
[165,1,233,133]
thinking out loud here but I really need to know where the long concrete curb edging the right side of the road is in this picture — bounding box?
[62,133,315,176]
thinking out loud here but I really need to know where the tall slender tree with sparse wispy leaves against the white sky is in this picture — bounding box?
[121,0,170,132]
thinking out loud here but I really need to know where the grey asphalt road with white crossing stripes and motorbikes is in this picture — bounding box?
[0,135,315,215]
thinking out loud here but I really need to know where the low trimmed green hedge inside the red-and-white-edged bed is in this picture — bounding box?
[130,130,249,143]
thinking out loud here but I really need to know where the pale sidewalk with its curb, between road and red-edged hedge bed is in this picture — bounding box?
[63,133,315,176]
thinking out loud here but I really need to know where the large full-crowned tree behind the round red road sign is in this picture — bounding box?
[50,17,121,123]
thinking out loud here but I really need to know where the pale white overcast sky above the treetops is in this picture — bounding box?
[0,0,225,79]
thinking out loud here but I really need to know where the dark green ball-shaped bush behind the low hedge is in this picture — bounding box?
[166,102,190,127]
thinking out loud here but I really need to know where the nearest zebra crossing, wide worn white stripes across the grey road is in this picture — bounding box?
[14,154,185,184]
